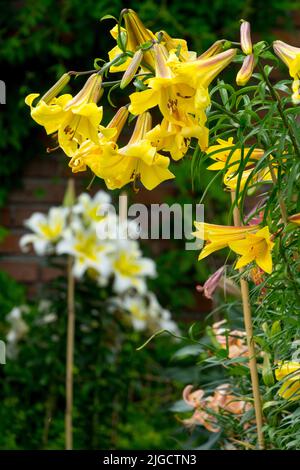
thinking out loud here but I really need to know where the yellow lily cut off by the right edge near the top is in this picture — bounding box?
[273,41,300,104]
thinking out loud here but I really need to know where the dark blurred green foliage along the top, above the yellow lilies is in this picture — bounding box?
[0,0,300,204]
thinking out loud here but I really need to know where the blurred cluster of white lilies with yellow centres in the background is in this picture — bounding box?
[20,191,177,332]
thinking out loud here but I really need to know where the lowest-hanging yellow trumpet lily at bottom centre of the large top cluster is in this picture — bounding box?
[93,113,174,190]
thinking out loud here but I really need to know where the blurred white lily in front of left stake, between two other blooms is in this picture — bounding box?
[56,226,113,279]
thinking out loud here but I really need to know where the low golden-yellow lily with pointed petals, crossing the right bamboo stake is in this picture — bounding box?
[194,222,274,273]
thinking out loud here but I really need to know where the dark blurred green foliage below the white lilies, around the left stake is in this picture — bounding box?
[0,275,189,449]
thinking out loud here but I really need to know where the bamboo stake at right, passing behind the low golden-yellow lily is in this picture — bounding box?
[231,191,264,449]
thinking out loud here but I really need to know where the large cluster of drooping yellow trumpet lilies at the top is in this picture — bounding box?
[26,10,237,190]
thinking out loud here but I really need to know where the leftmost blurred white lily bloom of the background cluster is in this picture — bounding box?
[20,207,68,256]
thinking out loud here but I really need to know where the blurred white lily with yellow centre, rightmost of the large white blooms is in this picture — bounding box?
[112,240,156,293]
